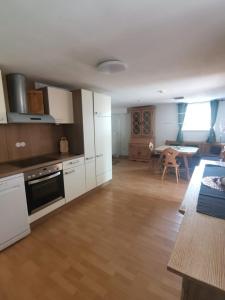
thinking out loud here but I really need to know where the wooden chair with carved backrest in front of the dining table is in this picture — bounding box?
[162,148,180,183]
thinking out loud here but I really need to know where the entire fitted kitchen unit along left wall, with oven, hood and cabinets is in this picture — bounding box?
[0,74,112,250]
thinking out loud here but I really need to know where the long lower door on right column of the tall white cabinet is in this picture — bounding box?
[95,115,112,185]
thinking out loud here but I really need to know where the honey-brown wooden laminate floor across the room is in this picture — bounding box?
[0,160,187,300]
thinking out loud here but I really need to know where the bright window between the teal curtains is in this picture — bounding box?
[182,102,211,131]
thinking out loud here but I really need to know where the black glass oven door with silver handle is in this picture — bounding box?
[25,171,65,215]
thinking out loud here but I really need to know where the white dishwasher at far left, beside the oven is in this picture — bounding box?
[0,174,30,250]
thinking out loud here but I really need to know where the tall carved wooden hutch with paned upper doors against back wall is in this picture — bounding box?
[129,105,155,161]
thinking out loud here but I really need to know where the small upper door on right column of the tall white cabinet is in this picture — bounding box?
[94,93,111,117]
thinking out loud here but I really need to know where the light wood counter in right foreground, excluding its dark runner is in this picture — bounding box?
[167,161,225,300]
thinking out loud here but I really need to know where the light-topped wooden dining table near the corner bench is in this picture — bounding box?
[155,145,199,180]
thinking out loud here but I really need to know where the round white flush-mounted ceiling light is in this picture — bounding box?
[96,59,127,74]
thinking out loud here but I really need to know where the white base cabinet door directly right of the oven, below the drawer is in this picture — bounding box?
[63,165,85,202]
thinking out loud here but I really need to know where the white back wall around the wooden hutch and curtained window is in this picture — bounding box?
[112,101,225,155]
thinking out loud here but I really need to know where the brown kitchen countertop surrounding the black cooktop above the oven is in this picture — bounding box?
[0,153,84,178]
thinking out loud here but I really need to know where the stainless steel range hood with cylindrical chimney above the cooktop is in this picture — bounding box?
[6,74,55,123]
